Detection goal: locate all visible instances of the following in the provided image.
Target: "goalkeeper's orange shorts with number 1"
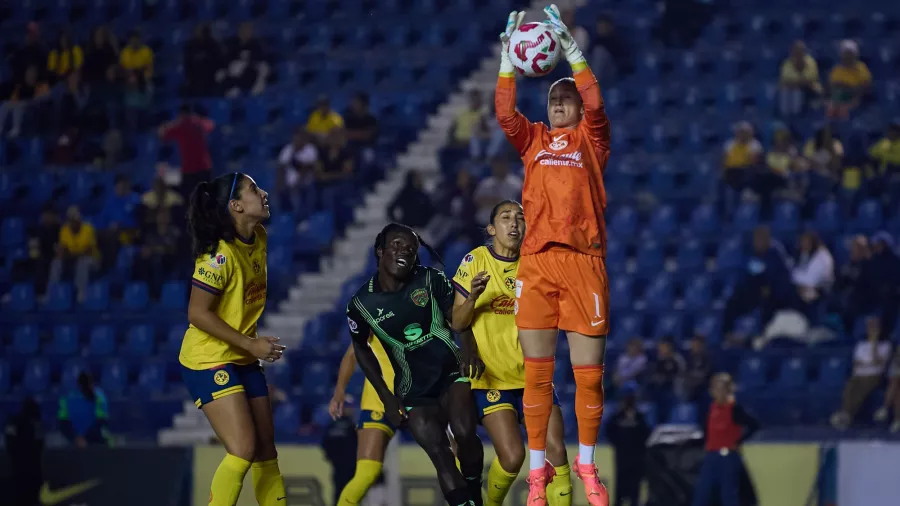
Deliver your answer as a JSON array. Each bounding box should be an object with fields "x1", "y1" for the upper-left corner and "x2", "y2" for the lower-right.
[{"x1": 515, "y1": 247, "x2": 609, "y2": 336}]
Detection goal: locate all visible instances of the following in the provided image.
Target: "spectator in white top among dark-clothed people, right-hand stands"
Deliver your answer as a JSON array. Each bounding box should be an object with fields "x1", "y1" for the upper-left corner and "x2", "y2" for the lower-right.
[{"x1": 791, "y1": 230, "x2": 834, "y2": 308}]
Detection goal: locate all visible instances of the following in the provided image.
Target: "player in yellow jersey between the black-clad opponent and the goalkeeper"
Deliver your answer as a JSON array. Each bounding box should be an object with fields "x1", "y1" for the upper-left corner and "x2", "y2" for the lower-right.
[{"x1": 453, "y1": 200, "x2": 572, "y2": 506}]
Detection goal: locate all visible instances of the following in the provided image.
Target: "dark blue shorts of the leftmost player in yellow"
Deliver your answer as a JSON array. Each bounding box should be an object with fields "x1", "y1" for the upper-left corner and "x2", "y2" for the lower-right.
[{"x1": 181, "y1": 362, "x2": 269, "y2": 408}]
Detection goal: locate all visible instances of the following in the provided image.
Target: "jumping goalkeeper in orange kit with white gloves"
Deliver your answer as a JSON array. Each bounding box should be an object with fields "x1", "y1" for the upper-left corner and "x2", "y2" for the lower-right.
[{"x1": 495, "y1": 5, "x2": 610, "y2": 506}]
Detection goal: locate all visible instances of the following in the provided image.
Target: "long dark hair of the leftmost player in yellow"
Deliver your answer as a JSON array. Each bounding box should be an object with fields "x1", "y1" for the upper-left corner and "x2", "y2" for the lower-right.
[{"x1": 188, "y1": 172, "x2": 247, "y2": 257}]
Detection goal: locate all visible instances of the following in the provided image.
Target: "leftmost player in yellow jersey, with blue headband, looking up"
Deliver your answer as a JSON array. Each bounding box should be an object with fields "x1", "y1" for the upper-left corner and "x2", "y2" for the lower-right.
[{"x1": 185, "y1": 172, "x2": 286, "y2": 506}]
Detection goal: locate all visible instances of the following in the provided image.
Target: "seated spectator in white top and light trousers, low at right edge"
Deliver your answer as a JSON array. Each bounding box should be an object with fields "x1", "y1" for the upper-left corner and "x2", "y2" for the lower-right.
[{"x1": 831, "y1": 316, "x2": 891, "y2": 430}]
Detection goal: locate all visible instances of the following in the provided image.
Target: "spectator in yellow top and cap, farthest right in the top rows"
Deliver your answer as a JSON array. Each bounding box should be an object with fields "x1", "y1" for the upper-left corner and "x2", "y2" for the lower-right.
[{"x1": 828, "y1": 39, "x2": 872, "y2": 119}]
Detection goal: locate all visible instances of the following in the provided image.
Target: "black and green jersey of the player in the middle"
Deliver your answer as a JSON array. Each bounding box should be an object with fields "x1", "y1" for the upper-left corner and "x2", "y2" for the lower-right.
[{"x1": 347, "y1": 266, "x2": 460, "y2": 407}]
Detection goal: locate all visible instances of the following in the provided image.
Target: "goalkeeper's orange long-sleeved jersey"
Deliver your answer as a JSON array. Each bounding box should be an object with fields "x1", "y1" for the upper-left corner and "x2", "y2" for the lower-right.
[{"x1": 494, "y1": 68, "x2": 609, "y2": 257}]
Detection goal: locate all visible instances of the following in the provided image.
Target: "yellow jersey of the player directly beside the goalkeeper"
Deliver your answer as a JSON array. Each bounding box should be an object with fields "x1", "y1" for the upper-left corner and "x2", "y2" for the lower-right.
[{"x1": 453, "y1": 246, "x2": 525, "y2": 390}]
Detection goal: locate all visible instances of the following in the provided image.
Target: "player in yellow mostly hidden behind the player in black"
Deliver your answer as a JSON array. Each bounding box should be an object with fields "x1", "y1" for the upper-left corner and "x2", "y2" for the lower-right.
[{"x1": 328, "y1": 336, "x2": 397, "y2": 506}]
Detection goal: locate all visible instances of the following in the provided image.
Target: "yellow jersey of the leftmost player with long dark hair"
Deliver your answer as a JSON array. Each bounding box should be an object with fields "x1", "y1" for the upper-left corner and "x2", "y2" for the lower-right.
[{"x1": 178, "y1": 225, "x2": 267, "y2": 370}]
